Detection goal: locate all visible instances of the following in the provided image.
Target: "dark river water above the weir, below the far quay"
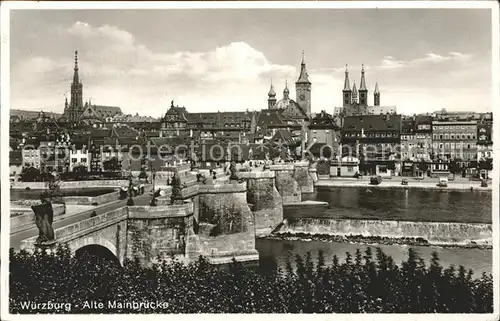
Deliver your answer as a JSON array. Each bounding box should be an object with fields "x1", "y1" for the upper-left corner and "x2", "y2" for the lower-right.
[{"x1": 296, "y1": 187, "x2": 492, "y2": 224}]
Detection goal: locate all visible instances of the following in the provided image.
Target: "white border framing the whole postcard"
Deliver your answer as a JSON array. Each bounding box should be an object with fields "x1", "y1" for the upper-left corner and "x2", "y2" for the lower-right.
[{"x1": 0, "y1": 1, "x2": 500, "y2": 321}]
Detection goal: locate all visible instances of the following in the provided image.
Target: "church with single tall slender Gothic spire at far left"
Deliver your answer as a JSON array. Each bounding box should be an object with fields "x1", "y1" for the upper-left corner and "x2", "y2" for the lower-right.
[{"x1": 59, "y1": 51, "x2": 123, "y2": 124}]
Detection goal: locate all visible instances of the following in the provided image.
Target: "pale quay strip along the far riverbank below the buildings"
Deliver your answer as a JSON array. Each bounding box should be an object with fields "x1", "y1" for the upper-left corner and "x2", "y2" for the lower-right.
[{"x1": 314, "y1": 177, "x2": 492, "y2": 192}]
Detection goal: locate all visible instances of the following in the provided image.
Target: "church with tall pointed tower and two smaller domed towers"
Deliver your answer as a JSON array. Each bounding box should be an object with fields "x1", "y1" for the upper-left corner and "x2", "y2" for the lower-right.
[{"x1": 267, "y1": 53, "x2": 311, "y2": 120}]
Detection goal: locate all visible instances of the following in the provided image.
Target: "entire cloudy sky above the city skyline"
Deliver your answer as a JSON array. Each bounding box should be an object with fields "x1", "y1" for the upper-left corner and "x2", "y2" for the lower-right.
[{"x1": 10, "y1": 9, "x2": 492, "y2": 117}]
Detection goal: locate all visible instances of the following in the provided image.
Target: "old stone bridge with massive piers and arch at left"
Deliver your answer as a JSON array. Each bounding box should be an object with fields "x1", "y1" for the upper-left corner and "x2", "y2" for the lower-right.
[{"x1": 21, "y1": 164, "x2": 314, "y2": 264}]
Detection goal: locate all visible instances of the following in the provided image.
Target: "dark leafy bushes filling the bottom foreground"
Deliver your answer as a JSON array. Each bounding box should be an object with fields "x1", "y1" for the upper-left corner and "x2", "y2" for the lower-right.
[{"x1": 9, "y1": 247, "x2": 493, "y2": 313}]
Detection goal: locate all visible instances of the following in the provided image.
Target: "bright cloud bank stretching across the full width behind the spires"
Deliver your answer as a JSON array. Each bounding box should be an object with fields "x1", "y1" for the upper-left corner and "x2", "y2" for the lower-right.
[{"x1": 11, "y1": 21, "x2": 491, "y2": 116}]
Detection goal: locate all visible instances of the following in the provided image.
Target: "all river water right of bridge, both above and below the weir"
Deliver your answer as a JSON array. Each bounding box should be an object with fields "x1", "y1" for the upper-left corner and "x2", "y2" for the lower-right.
[{"x1": 256, "y1": 187, "x2": 493, "y2": 277}]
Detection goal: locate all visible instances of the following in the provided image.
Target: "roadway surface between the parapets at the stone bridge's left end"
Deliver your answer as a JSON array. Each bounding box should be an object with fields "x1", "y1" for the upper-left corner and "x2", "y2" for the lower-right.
[{"x1": 9, "y1": 194, "x2": 151, "y2": 251}]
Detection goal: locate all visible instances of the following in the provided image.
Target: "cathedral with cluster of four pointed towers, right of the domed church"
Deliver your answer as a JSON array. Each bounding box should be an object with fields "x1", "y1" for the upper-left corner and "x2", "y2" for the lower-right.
[{"x1": 334, "y1": 65, "x2": 396, "y2": 116}]
